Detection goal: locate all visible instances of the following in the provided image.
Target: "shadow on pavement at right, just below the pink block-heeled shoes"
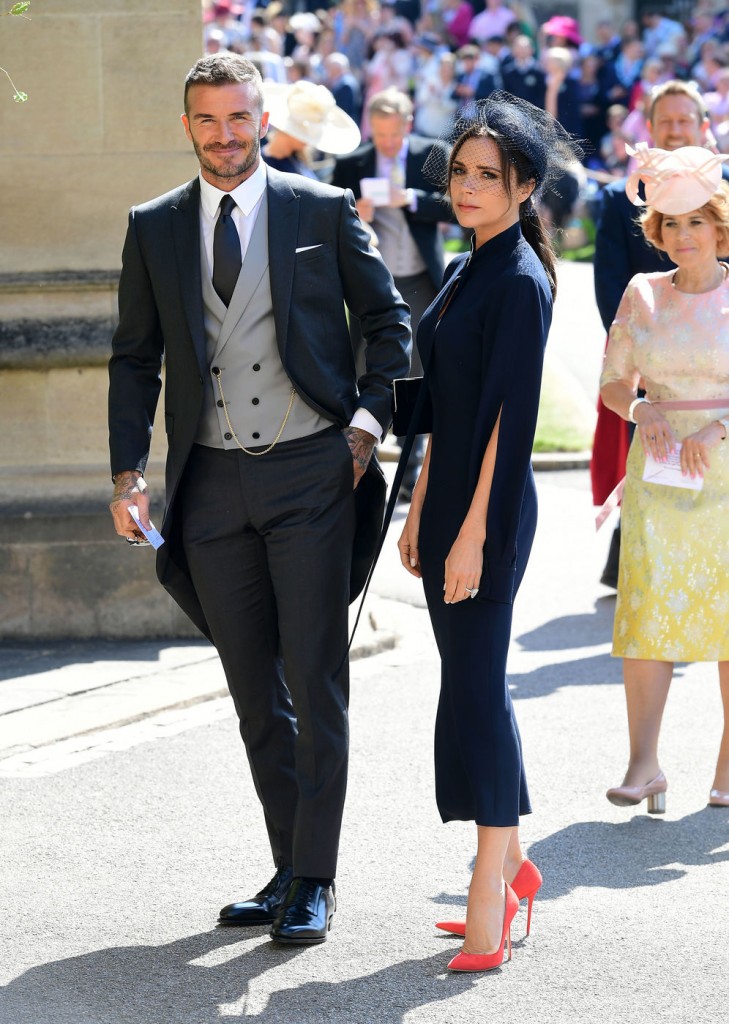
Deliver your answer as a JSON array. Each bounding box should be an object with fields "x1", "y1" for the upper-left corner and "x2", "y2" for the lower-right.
[{"x1": 528, "y1": 807, "x2": 729, "y2": 899}]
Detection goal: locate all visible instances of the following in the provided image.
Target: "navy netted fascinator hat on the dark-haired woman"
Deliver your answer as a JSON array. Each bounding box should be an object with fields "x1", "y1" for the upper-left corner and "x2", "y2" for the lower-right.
[{"x1": 423, "y1": 90, "x2": 585, "y2": 200}]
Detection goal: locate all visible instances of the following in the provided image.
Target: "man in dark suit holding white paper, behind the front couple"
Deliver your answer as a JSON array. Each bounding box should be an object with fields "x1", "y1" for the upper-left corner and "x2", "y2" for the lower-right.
[{"x1": 332, "y1": 89, "x2": 452, "y2": 501}]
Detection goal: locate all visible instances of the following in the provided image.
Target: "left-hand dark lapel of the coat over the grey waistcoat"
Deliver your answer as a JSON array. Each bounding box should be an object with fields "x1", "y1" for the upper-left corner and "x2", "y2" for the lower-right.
[{"x1": 172, "y1": 178, "x2": 208, "y2": 374}]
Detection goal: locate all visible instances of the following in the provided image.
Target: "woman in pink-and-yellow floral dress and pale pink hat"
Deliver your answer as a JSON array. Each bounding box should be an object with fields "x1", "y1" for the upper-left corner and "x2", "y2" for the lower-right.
[{"x1": 600, "y1": 146, "x2": 729, "y2": 813}]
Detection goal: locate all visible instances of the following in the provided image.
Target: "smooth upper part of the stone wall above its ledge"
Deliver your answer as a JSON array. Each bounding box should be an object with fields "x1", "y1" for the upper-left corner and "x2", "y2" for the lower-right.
[{"x1": 0, "y1": 0, "x2": 203, "y2": 273}]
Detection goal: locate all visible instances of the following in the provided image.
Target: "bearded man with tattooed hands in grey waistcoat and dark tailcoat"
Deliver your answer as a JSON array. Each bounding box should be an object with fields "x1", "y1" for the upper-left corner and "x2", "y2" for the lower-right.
[{"x1": 110, "y1": 54, "x2": 410, "y2": 944}]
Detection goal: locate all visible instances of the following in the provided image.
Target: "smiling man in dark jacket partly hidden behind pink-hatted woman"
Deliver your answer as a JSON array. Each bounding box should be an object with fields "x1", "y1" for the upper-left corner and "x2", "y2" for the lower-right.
[{"x1": 591, "y1": 80, "x2": 729, "y2": 588}]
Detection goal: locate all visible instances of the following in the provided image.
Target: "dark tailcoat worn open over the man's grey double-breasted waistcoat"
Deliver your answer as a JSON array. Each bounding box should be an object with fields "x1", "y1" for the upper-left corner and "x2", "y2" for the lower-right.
[{"x1": 109, "y1": 168, "x2": 411, "y2": 633}]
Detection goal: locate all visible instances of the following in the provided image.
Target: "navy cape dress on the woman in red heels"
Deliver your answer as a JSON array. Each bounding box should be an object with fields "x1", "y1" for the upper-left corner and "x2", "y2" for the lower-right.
[{"x1": 418, "y1": 224, "x2": 552, "y2": 827}]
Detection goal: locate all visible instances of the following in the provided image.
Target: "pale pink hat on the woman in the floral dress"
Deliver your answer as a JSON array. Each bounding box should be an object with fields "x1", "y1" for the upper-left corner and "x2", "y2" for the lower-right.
[{"x1": 626, "y1": 142, "x2": 729, "y2": 216}]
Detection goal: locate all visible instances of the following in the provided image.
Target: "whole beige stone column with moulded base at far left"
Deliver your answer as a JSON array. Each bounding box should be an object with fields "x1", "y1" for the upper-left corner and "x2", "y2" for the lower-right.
[{"x1": 0, "y1": 0, "x2": 203, "y2": 637}]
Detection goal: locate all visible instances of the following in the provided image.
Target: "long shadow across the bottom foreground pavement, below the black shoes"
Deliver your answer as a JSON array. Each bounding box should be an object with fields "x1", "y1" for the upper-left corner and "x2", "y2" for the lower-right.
[{"x1": 0, "y1": 930, "x2": 487, "y2": 1024}]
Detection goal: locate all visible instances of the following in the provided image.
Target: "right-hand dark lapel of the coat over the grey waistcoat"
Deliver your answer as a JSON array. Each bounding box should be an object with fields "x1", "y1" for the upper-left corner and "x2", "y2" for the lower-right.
[{"x1": 266, "y1": 167, "x2": 301, "y2": 366}]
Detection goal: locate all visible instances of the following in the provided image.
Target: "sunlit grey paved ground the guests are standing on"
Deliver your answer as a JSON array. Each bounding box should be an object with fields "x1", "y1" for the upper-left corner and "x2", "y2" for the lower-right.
[{"x1": 0, "y1": 260, "x2": 729, "y2": 1024}]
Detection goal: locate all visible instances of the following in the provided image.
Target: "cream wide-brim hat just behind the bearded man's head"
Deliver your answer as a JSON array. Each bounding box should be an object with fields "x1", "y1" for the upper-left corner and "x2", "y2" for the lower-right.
[{"x1": 263, "y1": 81, "x2": 361, "y2": 155}]
